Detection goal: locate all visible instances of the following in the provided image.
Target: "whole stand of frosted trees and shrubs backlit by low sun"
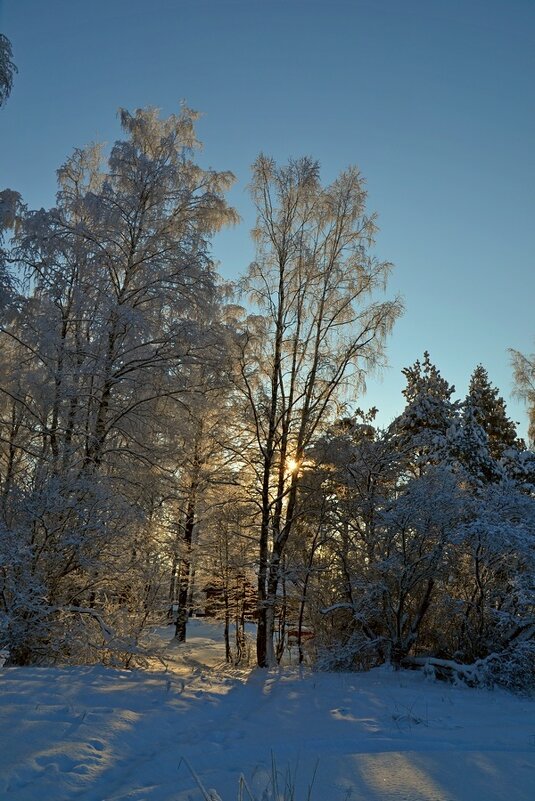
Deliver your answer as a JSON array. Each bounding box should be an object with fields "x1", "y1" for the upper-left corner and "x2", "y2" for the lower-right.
[{"x1": 0, "y1": 101, "x2": 535, "y2": 689}]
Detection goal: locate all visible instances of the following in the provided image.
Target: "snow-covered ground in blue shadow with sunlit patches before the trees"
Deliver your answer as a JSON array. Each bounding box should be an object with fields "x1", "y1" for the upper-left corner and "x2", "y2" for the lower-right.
[{"x1": 0, "y1": 620, "x2": 535, "y2": 801}]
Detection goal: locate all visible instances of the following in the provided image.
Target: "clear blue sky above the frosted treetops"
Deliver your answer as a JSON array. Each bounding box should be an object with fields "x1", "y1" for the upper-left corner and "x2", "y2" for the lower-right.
[{"x1": 0, "y1": 0, "x2": 535, "y2": 435}]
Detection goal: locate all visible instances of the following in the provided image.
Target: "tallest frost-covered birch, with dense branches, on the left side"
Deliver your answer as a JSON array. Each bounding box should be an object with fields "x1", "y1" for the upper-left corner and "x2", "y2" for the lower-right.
[{"x1": 0, "y1": 108, "x2": 234, "y2": 661}]
